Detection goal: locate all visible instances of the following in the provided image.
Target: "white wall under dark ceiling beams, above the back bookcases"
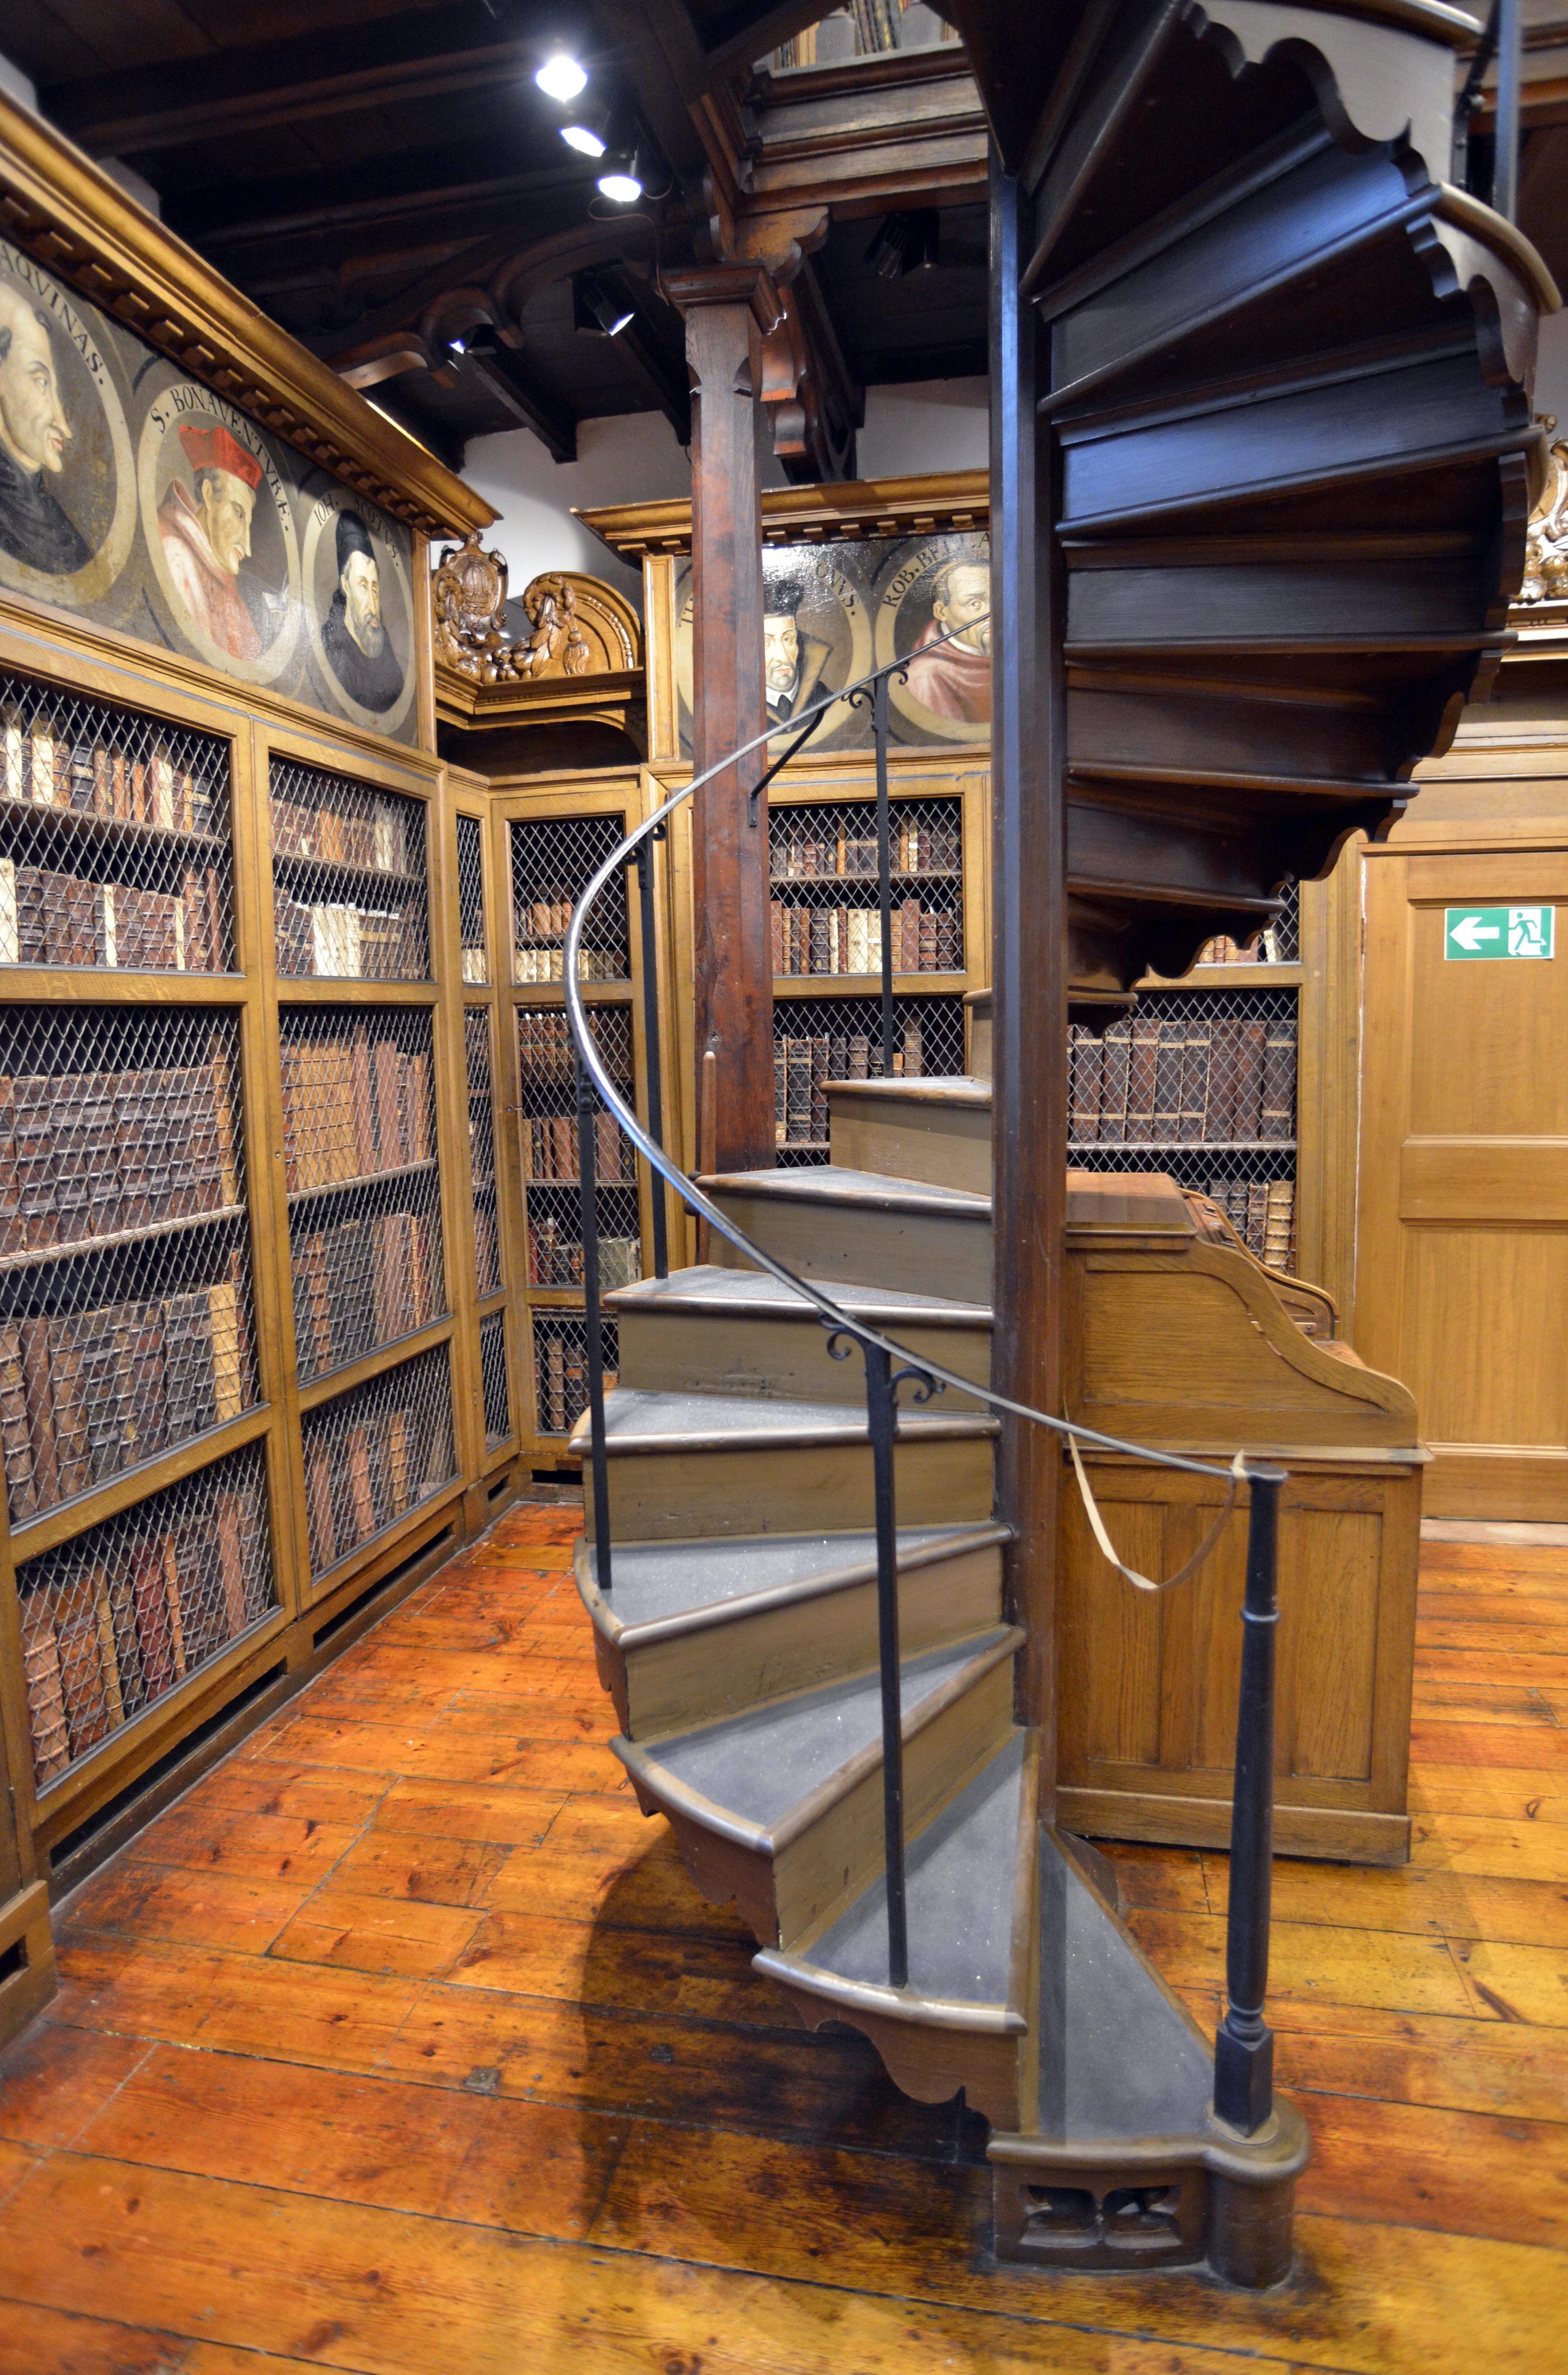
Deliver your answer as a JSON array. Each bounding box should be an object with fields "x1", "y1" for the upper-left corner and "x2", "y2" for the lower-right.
[{"x1": 463, "y1": 380, "x2": 988, "y2": 601}]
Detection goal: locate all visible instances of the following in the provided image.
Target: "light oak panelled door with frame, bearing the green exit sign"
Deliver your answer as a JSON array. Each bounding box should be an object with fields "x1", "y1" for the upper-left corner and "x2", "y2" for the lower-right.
[{"x1": 1359, "y1": 821, "x2": 1568, "y2": 1522}]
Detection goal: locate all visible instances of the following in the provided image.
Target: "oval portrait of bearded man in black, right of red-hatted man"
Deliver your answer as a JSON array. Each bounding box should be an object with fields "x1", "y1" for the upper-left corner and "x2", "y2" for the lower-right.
[{"x1": 304, "y1": 484, "x2": 416, "y2": 734}]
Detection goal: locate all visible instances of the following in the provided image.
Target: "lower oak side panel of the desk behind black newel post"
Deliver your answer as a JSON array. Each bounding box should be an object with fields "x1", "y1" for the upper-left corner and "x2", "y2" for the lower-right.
[{"x1": 1059, "y1": 1453, "x2": 1421, "y2": 1862}]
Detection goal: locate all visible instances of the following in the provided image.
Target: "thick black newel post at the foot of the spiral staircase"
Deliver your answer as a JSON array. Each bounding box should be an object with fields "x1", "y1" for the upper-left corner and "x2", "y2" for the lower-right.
[{"x1": 1214, "y1": 1468, "x2": 1285, "y2": 2135}]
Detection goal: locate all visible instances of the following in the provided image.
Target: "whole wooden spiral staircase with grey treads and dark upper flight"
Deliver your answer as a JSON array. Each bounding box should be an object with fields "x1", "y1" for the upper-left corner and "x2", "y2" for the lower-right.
[{"x1": 565, "y1": 0, "x2": 1556, "y2": 2285}]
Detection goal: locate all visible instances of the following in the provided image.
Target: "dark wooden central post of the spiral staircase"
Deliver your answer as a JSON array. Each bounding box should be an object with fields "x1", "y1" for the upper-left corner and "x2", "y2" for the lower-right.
[{"x1": 991, "y1": 161, "x2": 1067, "y2": 1776}]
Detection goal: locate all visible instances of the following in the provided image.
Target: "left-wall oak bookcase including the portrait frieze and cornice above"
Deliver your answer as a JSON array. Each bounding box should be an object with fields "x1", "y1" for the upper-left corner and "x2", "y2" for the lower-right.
[{"x1": 0, "y1": 100, "x2": 518, "y2": 2038}]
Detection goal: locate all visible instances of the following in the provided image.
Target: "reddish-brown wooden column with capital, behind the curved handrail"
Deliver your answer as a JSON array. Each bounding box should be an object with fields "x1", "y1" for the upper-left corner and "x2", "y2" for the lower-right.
[{"x1": 665, "y1": 264, "x2": 779, "y2": 1171}]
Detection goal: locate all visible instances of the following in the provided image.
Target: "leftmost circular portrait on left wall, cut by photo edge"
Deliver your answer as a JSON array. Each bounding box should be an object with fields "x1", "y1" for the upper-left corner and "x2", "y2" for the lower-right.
[{"x1": 0, "y1": 244, "x2": 135, "y2": 606}]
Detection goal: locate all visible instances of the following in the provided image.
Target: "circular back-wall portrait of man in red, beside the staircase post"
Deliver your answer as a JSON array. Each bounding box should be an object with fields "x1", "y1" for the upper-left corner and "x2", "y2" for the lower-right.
[{"x1": 877, "y1": 534, "x2": 991, "y2": 741}]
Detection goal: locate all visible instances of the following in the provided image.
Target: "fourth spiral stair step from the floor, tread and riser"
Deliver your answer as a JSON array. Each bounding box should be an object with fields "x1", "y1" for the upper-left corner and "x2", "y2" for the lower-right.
[{"x1": 575, "y1": 1525, "x2": 1012, "y2": 1741}]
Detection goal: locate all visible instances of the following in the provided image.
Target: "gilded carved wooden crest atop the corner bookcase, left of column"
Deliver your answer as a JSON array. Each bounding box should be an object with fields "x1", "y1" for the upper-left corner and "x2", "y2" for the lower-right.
[{"x1": 430, "y1": 534, "x2": 642, "y2": 684}]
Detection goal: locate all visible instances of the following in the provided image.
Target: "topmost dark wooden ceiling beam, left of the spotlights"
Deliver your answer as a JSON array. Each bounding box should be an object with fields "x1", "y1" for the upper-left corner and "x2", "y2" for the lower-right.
[{"x1": 40, "y1": 7, "x2": 558, "y2": 157}]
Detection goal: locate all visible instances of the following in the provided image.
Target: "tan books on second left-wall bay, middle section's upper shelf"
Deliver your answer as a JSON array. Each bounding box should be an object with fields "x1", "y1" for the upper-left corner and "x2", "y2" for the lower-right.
[{"x1": 283, "y1": 1024, "x2": 435, "y2": 1195}]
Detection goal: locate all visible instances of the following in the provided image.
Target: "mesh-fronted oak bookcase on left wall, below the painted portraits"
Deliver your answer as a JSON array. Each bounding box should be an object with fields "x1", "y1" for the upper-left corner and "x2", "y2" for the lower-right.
[{"x1": 0, "y1": 617, "x2": 532, "y2": 1954}]
